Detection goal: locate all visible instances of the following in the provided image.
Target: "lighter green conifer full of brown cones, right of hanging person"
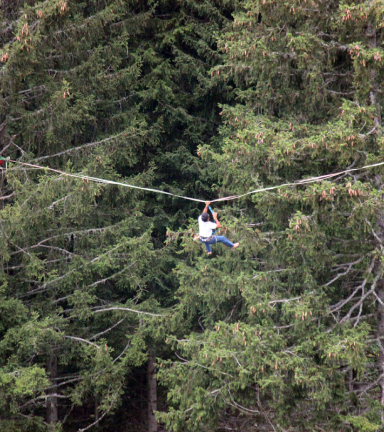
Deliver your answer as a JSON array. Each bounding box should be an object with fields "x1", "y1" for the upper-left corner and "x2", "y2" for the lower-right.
[{"x1": 161, "y1": 0, "x2": 384, "y2": 431}]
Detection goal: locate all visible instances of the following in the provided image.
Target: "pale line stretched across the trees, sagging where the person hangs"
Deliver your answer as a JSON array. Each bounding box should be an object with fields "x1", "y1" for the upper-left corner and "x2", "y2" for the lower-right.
[{"x1": 9, "y1": 159, "x2": 384, "y2": 203}]
